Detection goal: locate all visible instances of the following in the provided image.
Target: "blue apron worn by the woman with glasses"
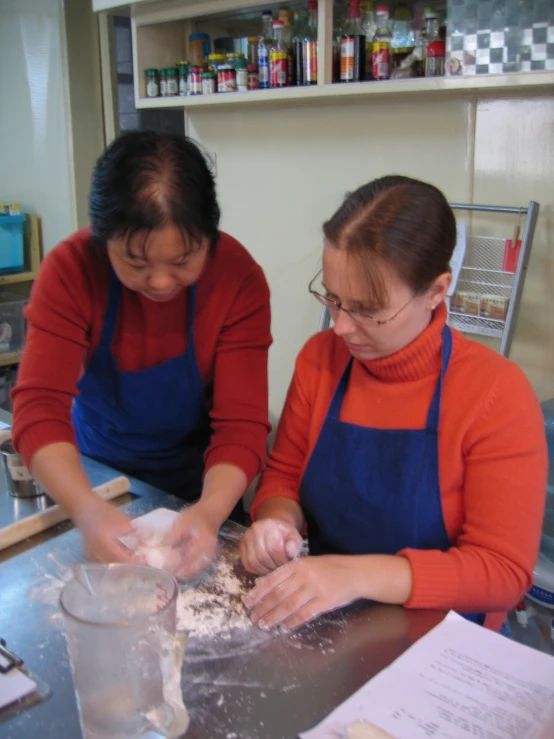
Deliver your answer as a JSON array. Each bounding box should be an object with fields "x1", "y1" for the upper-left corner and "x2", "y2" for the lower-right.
[{"x1": 300, "y1": 326, "x2": 485, "y2": 624}]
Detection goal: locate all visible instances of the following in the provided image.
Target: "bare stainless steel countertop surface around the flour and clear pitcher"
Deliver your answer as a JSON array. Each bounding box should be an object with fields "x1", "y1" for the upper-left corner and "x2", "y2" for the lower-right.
[{"x1": 0, "y1": 448, "x2": 442, "y2": 739}]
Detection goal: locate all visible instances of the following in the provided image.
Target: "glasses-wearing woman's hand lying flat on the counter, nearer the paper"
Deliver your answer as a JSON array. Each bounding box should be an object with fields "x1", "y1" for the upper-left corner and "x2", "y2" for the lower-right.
[{"x1": 244, "y1": 555, "x2": 362, "y2": 629}]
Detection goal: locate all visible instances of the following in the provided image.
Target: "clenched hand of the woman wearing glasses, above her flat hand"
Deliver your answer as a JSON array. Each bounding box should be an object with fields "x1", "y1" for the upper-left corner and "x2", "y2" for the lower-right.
[{"x1": 239, "y1": 518, "x2": 302, "y2": 575}]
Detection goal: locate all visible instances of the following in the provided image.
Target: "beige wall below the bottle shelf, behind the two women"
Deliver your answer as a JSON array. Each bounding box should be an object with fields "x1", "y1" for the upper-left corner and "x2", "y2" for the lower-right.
[{"x1": 187, "y1": 91, "x2": 554, "y2": 416}]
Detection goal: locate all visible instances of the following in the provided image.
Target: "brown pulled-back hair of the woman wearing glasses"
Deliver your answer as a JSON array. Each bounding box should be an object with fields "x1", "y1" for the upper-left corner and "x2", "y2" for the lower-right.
[{"x1": 323, "y1": 175, "x2": 456, "y2": 307}]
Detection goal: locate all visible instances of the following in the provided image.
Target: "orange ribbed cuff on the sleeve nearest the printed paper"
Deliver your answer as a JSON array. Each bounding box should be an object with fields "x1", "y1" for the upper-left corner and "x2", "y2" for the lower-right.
[{"x1": 398, "y1": 549, "x2": 458, "y2": 611}]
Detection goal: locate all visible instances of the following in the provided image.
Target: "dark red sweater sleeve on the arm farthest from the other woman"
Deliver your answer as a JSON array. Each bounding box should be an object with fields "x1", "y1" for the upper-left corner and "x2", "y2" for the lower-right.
[{"x1": 13, "y1": 243, "x2": 91, "y2": 466}]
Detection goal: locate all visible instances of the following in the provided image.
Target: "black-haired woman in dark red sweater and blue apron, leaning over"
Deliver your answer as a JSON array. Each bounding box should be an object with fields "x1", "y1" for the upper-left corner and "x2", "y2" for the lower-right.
[{"x1": 13, "y1": 132, "x2": 271, "y2": 574}]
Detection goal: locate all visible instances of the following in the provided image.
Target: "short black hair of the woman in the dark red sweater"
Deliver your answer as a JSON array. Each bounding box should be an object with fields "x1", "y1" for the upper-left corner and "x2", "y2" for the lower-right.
[{"x1": 89, "y1": 131, "x2": 220, "y2": 258}]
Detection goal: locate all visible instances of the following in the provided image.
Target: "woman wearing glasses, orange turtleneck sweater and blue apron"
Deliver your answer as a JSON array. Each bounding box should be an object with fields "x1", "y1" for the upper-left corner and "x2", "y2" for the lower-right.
[{"x1": 241, "y1": 177, "x2": 547, "y2": 629}]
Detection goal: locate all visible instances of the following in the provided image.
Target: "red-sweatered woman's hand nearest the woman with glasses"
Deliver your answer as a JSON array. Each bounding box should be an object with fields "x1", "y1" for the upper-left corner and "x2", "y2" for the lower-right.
[{"x1": 164, "y1": 501, "x2": 218, "y2": 579}]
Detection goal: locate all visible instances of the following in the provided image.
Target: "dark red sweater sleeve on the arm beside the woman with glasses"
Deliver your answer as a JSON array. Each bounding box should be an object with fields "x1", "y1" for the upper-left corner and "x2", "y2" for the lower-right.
[{"x1": 205, "y1": 265, "x2": 271, "y2": 484}]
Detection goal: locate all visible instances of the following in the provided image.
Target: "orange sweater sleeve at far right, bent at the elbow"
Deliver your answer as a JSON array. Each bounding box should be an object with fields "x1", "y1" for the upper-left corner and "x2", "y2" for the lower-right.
[{"x1": 399, "y1": 363, "x2": 547, "y2": 613}]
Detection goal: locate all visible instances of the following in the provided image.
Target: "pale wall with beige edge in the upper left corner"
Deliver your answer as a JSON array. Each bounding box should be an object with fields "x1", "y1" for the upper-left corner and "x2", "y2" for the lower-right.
[{"x1": 0, "y1": 0, "x2": 103, "y2": 251}]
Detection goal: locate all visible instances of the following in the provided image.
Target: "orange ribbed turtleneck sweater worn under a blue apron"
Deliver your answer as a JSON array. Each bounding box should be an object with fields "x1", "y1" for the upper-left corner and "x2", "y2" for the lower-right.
[{"x1": 252, "y1": 306, "x2": 547, "y2": 630}]
